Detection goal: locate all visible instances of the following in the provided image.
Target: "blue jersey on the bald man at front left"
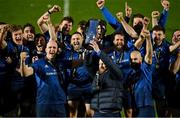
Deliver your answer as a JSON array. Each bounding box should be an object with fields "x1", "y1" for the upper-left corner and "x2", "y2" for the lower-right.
[{"x1": 32, "y1": 58, "x2": 66, "y2": 104}]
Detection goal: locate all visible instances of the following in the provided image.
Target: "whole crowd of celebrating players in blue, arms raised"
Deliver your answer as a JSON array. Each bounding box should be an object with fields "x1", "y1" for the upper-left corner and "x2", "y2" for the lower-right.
[{"x1": 0, "y1": 0, "x2": 180, "y2": 117}]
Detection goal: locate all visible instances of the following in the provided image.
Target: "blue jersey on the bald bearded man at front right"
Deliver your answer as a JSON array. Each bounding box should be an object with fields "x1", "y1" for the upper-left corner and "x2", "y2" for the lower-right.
[{"x1": 129, "y1": 62, "x2": 154, "y2": 107}]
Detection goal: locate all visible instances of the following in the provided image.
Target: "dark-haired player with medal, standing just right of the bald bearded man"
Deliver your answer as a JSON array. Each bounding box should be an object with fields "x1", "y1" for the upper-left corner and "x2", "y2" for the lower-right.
[{"x1": 152, "y1": 26, "x2": 170, "y2": 117}]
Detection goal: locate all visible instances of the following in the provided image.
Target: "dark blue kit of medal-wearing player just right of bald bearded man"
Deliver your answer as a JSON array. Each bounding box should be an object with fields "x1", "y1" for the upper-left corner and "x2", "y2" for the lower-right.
[{"x1": 152, "y1": 41, "x2": 170, "y2": 99}]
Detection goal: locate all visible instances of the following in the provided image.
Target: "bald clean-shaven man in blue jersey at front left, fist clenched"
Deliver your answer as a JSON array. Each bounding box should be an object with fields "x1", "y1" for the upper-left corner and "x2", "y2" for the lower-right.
[{"x1": 21, "y1": 40, "x2": 66, "y2": 117}]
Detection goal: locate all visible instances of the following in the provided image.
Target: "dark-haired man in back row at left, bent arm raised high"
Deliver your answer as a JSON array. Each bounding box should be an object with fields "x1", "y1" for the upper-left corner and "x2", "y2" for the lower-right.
[{"x1": 37, "y1": 5, "x2": 74, "y2": 50}]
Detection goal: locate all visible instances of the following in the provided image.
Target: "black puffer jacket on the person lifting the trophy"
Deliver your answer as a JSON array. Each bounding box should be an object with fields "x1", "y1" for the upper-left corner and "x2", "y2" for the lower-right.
[{"x1": 85, "y1": 52, "x2": 124, "y2": 111}]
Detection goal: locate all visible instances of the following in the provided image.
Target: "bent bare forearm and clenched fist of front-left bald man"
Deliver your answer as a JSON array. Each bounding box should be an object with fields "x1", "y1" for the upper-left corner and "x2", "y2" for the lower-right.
[{"x1": 20, "y1": 52, "x2": 34, "y2": 77}]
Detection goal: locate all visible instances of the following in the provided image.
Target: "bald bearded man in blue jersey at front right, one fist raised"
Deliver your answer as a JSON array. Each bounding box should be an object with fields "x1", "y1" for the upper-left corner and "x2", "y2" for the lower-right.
[{"x1": 126, "y1": 28, "x2": 155, "y2": 117}]
